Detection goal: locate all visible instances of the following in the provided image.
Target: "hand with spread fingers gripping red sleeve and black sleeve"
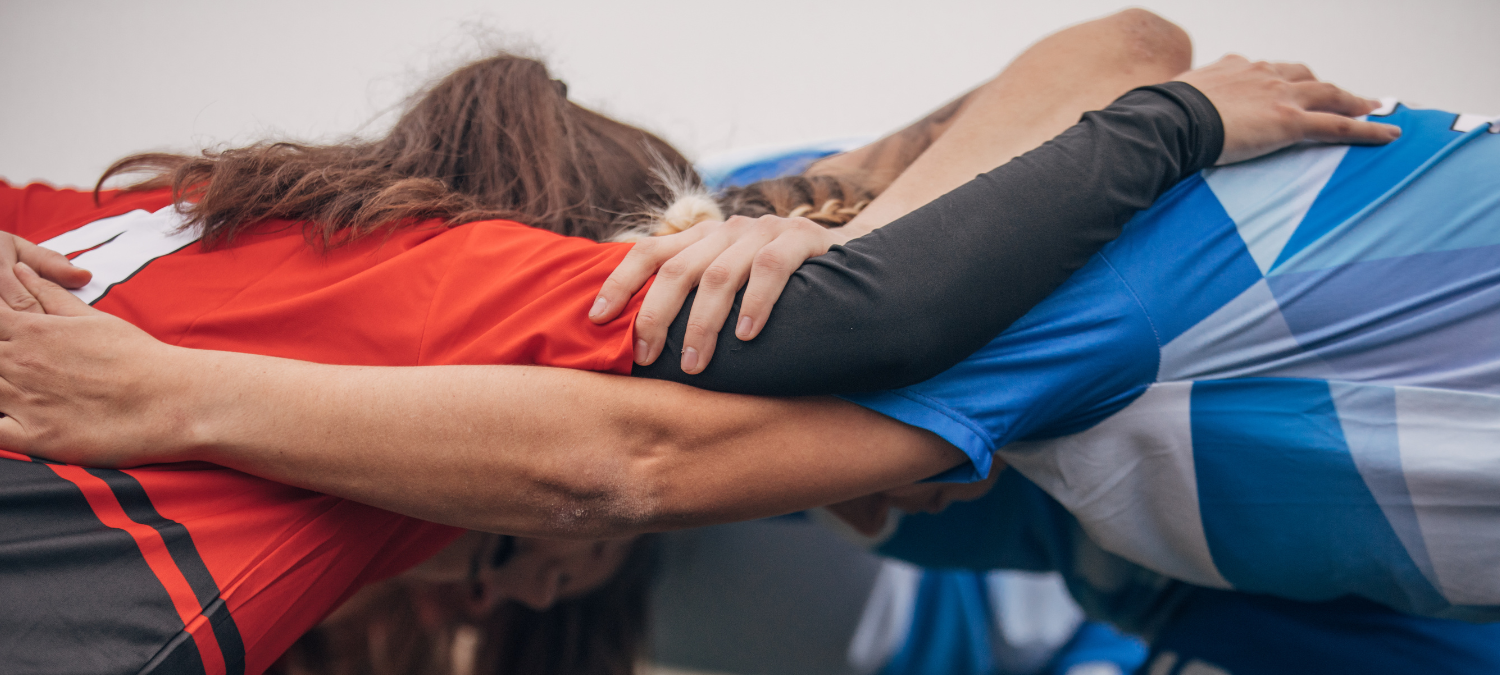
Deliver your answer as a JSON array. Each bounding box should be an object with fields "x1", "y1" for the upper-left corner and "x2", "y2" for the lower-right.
[{"x1": 588, "y1": 216, "x2": 849, "y2": 374}]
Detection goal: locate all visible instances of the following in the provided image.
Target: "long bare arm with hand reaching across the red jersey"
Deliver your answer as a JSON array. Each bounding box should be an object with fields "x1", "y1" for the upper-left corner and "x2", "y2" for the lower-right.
[{"x1": 0, "y1": 267, "x2": 963, "y2": 537}]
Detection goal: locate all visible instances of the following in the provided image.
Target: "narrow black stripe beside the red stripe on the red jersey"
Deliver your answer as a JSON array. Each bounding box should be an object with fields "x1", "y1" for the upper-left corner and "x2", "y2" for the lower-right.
[{"x1": 89, "y1": 470, "x2": 245, "y2": 675}]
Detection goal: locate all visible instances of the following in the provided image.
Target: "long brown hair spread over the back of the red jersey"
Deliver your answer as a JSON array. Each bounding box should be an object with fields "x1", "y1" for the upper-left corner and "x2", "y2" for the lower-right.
[{"x1": 95, "y1": 54, "x2": 696, "y2": 248}]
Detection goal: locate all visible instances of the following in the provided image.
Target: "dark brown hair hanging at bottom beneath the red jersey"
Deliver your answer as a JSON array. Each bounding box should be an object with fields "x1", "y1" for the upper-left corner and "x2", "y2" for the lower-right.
[{"x1": 269, "y1": 536, "x2": 656, "y2": 675}]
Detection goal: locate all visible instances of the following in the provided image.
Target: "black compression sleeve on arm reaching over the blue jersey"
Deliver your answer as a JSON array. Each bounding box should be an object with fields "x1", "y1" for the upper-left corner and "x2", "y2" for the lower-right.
[{"x1": 633, "y1": 83, "x2": 1224, "y2": 396}]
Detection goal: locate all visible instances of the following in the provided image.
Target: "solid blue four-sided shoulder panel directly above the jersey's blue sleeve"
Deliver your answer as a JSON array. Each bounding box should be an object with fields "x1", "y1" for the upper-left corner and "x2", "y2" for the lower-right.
[{"x1": 1101, "y1": 176, "x2": 1262, "y2": 345}]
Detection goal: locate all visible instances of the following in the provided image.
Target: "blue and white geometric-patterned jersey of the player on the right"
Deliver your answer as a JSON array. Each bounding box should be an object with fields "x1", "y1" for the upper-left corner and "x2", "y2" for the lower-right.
[{"x1": 848, "y1": 104, "x2": 1500, "y2": 620}]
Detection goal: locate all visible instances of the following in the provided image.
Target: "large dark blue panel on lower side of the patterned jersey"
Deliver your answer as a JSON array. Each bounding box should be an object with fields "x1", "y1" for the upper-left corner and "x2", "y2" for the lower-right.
[{"x1": 1191, "y1": 378, "x2": 1448, "y2": 611}]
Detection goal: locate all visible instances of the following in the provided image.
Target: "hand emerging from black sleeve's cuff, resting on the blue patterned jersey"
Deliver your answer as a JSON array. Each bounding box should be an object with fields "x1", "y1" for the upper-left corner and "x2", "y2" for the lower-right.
[{"x1": 1178, "y1": 54, "x2": 1401, "y2": 165}]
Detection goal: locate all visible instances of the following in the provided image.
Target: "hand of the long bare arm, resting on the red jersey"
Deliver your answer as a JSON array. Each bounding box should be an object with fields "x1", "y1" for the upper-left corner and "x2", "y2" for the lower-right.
[{"x1": 0, "y1": 263, "x2": 191, "y2": 467}]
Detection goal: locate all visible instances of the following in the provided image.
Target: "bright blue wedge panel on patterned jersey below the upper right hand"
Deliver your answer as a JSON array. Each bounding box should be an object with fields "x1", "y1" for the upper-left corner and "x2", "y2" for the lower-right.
[{"x1": 1271, "y1": 105, "x2": 1463, "y2": 270}]
